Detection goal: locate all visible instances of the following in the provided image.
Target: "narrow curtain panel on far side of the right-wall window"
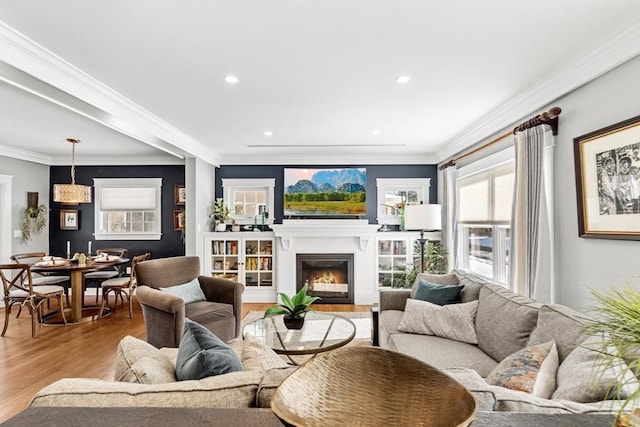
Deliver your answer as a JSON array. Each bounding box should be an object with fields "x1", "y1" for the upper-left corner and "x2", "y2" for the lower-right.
[{"x1": 438, "y1": 165, "x2": 458, "y2": 271}]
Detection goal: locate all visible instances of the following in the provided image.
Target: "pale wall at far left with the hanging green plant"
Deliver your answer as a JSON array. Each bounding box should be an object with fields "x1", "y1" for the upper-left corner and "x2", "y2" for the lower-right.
[{"x1": 0, "y1": 156, "x2": 50, "y2": 253}]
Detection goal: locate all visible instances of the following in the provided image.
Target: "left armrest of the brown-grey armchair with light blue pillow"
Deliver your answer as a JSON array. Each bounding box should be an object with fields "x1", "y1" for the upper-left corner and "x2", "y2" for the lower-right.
[{"x1": 136, "y1": 286, "x2": 185, "y2": 348}]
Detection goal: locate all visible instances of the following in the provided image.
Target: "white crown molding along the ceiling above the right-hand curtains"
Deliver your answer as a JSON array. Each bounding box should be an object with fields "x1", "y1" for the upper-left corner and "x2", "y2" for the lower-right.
[{"x1": 436, "y1": 23, "x2": 640, "y2": 163}]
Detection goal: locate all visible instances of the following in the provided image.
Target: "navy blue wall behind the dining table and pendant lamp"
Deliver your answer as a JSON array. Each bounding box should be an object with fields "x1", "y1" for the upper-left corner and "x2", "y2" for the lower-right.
[{"x1": 49, "y1": 165, "x2": 184, "y2": 258}]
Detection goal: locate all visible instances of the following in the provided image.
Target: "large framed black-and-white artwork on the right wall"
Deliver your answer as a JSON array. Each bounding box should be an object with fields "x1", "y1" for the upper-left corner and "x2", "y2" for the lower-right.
[{"x1": 573, "y1": 116, "x2": 640, "y2": 240}]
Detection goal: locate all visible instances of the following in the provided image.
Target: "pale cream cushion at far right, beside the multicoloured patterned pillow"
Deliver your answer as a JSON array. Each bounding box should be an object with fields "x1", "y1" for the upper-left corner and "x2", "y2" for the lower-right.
[{"x1": 552, "y1": 337, "x2": 640, "y2": 403}]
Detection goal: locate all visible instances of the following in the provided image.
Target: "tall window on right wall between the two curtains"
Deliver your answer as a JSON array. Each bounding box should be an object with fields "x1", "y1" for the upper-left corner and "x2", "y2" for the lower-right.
[{"x1": 457, "y1": 150, "x2": 515, "y2": 283}]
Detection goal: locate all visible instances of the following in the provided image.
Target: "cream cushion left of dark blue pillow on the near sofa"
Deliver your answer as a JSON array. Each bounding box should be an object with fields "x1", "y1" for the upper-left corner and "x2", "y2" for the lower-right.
[{"x1": 114, "y1": 335, "x2": 176, "y2": 384}]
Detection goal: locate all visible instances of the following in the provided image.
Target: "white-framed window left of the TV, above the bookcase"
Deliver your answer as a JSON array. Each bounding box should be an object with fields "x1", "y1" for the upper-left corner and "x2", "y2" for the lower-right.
[{"x1": 222, "y1": 178, "x2": 276, "y2": 224}]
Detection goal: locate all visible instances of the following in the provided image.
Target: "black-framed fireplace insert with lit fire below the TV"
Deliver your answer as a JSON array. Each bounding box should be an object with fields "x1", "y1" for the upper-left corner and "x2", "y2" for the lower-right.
[{"x1": 296, "y1": 253, "x2": 353, "y2": 304}]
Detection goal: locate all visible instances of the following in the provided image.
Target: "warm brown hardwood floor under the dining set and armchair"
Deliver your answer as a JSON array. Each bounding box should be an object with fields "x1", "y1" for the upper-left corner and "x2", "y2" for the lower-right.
[{"x1": 0, "y1": 295, "x2": 369, "y2": 423}]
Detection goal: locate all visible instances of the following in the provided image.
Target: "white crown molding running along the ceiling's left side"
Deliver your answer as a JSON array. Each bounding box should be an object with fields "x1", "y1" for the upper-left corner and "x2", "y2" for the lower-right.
[{"x1": 0, "y1": 21, "x2": 219, "y2": 165}]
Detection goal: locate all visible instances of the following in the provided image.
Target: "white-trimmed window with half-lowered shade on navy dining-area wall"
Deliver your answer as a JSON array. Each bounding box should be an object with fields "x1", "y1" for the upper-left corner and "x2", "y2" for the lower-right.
[{"x1": 93, "y1": 178, "x2": 162, "y2": 240}]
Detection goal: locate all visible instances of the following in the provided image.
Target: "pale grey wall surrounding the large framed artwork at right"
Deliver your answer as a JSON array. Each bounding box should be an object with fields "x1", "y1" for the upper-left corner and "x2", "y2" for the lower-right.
[{"x1": 550, "y1": 57, "x2": 640, "y2": 310}]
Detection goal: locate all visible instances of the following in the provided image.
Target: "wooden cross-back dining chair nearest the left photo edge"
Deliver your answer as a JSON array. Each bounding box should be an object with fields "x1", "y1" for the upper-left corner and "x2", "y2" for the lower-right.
[{"x1": 0, "y1": 264, "x2": 67, "y2": 338}]
